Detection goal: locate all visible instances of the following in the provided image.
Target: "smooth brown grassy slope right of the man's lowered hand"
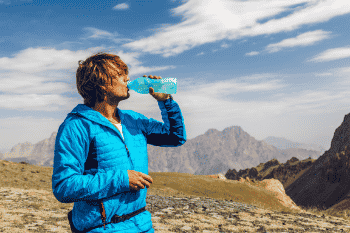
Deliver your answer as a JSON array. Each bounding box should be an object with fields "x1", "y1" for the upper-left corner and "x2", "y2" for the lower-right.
[{"x1": 148, "y1": 172, "x2": 350, "y2": 220}]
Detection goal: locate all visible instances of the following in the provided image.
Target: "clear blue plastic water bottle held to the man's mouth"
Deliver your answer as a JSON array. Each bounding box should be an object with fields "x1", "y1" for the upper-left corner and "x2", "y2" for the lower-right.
[{"x1": 127, "y1": 77, "x2": 177, "y2": 94}]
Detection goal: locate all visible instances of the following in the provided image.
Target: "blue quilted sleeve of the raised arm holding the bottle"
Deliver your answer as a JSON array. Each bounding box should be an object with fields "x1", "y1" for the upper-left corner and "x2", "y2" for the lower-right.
[{"x1": 142, "y1": 99, "x2": 186, "y2": 147}]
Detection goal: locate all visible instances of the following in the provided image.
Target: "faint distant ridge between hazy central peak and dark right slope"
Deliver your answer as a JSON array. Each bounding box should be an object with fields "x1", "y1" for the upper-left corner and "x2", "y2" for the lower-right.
[{"x1": 263, "y1": 136, "x2": 325, "y2": 155}]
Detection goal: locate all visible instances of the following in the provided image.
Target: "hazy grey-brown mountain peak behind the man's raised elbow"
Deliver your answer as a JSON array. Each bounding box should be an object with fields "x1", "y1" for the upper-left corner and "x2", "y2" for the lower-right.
[{"x1": 148, "y1": 126, "x2": 282, "y2": 175}]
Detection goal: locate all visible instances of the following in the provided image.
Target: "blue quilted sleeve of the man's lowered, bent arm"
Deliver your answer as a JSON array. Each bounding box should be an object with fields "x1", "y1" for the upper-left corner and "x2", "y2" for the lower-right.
[{"x1": 52, "y1": 119, "x2": 130, "y2": 203}]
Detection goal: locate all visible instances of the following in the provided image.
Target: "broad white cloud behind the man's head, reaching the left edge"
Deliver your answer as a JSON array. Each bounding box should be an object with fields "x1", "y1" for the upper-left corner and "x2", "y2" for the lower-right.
[{"x1": 0, "y1": 48, "x2": 175, "y2": 111}]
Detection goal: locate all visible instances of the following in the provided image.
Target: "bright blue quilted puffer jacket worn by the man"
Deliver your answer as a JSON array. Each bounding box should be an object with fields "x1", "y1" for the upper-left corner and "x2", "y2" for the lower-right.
[{"x1": 52, "y1": 99, "x2": 186, "y2": 233}]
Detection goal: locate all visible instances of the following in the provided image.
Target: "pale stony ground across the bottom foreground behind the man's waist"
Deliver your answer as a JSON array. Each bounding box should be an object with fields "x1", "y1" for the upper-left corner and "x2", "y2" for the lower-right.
[{"x1": 0, "y1": 187, "x2": 350, "y2": 233}]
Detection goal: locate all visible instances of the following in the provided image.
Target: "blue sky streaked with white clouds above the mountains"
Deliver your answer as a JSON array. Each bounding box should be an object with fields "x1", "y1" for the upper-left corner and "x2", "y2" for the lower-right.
[{"x1": 0, "y1": 0, "x2": 350, "y2": 150}]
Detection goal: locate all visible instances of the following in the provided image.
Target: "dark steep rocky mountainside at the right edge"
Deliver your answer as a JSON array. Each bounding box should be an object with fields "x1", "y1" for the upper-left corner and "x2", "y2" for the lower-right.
[{"x1": 286, "y1": 114, "x2": 350, "y2": 209}]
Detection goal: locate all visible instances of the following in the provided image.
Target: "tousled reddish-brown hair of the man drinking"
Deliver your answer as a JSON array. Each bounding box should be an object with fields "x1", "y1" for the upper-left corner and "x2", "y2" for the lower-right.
[{"x1": 76, "y1": 53, "x2": 129, "y2": 107}]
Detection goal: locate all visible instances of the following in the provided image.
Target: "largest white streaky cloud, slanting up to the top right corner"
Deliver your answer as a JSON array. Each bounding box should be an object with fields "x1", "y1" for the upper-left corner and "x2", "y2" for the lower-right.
[{"x1": 124, "y1": 0, "x2": 350, "y2": 57}]
